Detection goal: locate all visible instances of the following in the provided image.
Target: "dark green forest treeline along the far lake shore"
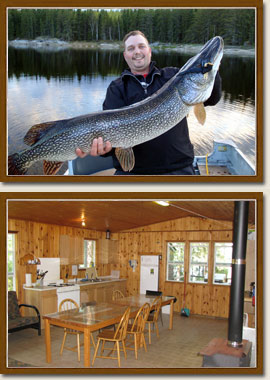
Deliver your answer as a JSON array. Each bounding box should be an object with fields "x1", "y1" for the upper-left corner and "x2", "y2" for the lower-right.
[{"x1": 8, "y1": 9, "x2": 255, "y2": 46}]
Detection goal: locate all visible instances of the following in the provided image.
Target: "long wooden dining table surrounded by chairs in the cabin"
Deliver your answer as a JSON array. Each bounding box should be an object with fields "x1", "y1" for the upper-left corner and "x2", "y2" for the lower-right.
[{"x1": 43, "y1": 295, "x2": 174, "y2": 367}]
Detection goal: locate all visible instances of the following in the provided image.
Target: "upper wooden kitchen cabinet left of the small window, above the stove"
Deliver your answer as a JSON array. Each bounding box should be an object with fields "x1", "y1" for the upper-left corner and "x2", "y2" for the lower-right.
[{"x1": 59, "y1": 235, "x2": 84, "y2": 265}]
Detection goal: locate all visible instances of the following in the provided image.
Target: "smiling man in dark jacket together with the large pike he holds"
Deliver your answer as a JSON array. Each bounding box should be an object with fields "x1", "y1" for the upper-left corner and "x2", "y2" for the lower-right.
[{"x1": 8, "y1": 31, "x2": 224, "y2": 175}]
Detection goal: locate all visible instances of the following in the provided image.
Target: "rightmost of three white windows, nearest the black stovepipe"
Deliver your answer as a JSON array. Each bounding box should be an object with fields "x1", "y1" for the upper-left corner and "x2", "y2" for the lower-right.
[{"x1": 213, "y1": 243, "x2": 233, "y2": 285}]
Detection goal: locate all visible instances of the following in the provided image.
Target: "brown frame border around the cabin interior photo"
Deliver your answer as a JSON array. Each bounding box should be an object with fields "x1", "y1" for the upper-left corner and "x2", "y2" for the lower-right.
[{"x1": 0, "y1": 192, "x2": 264, "y2": 375}]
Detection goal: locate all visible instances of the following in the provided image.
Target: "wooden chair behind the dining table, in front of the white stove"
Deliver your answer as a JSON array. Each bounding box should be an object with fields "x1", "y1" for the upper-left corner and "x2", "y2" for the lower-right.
[{"x1": 58, "y1": 298, "x2": 96, "y2": 361}]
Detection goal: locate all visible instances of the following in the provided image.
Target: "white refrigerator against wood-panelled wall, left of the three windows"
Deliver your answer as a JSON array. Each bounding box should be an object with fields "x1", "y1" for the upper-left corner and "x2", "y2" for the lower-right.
[{"x1": 140, "y1": 255, "x2": 159, "y2": 294}]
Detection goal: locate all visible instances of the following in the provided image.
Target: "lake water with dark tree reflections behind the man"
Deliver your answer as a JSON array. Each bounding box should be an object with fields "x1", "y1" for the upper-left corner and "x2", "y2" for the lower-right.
[{"x1": 8, "y1": 47, "x2": 256, "y2": 174}]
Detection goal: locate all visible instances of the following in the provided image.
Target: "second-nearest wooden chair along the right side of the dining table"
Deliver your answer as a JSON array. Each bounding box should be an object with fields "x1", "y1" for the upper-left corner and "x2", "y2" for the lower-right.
[{"x1": 126, "y1": 303, "x2": 150, "y2": 359}]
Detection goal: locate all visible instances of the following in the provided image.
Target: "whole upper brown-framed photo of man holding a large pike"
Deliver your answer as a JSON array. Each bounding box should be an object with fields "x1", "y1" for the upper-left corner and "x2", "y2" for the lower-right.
[{"x1": 0, "y1": 0, "x2": 263, "y2": 183}]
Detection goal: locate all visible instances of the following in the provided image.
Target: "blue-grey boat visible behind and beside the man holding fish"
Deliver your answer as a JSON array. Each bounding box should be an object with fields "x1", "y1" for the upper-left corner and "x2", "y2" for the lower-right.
[{"x1": 65, "y1": 140, "x2": 255, "y2": 176}]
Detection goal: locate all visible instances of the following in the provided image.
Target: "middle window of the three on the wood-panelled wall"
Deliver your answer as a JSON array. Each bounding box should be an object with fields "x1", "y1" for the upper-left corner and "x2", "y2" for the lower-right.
[{"x1": 189, "y1": 243, "x2": 209, "y2": 283}]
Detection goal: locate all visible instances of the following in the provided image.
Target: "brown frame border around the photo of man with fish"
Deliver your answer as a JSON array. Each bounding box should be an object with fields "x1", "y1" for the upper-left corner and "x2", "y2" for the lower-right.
[{"x1": 0, "y1": 0, "x2": 263, "y2": 183}]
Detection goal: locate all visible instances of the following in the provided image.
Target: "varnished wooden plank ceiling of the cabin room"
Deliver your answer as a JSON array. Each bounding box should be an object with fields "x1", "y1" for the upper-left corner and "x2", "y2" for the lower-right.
[{"x1": 8, "y1": 199, "x2": 255, "y2": 232}]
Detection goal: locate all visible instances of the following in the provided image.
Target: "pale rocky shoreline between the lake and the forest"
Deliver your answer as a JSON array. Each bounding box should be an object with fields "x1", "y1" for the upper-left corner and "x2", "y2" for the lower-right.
[{"x1": 8, "y1": 37, "x2": 255, "y2": 57}]
